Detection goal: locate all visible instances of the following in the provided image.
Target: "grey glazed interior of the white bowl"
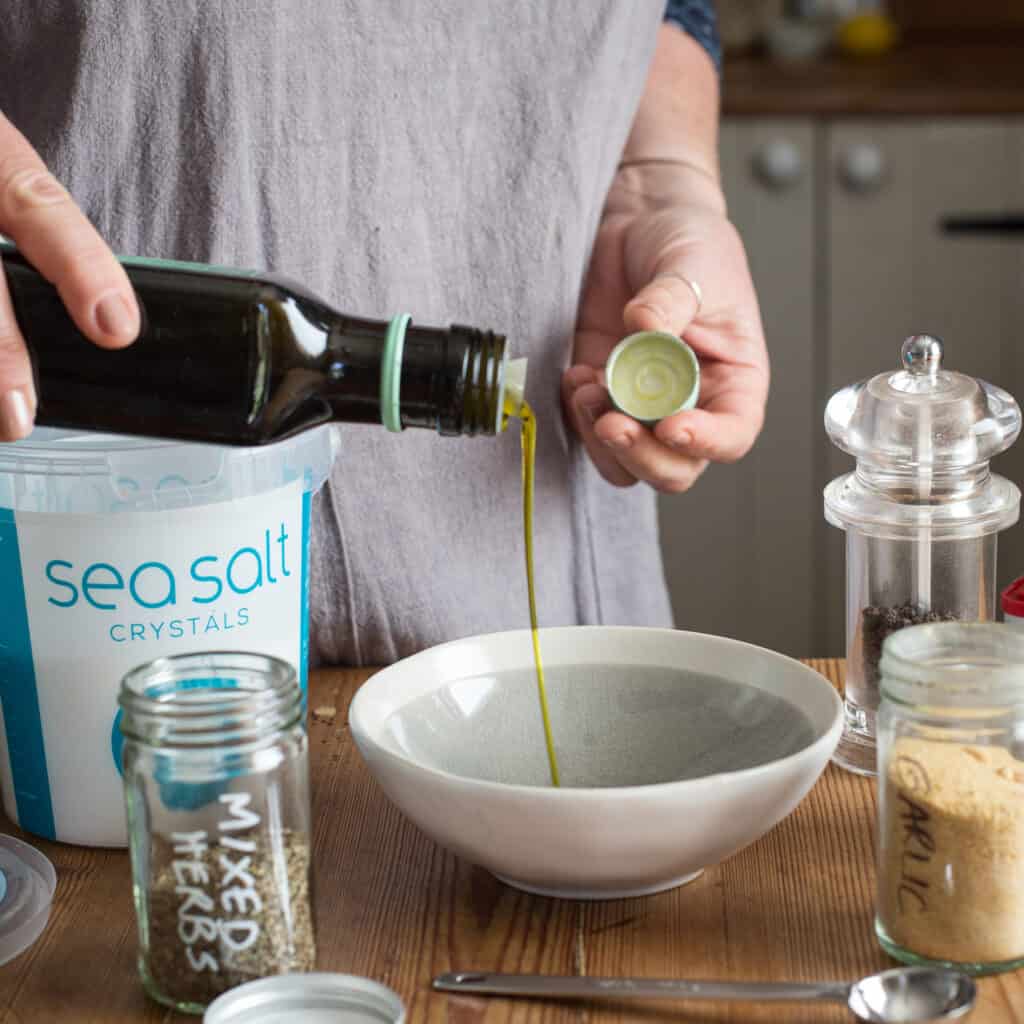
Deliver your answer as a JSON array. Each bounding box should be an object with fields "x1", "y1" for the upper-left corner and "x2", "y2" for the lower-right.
[{"x1": 382, "y1": 665, "x2": 814, "y2": 787}]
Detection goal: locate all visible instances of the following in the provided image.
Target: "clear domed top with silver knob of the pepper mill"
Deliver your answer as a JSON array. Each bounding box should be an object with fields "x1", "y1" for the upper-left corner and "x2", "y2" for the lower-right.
[{"x1": 825, "y1": 335, "x2": 1021, "y2": 473}]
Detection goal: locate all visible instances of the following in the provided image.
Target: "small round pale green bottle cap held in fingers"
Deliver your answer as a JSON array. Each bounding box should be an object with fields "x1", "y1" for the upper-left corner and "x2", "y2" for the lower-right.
[{"x1": 604, "y1": 331, "x2": 700, "y2": 423}]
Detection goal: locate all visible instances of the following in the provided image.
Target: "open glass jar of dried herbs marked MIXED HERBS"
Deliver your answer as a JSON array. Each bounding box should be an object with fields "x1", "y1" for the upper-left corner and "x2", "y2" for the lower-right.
[{"x1": 120, "y1": 652, "x2": 315, "y2": 1013}]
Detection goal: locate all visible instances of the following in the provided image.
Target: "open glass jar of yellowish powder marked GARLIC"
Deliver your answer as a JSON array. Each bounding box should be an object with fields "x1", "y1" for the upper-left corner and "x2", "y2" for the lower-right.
[{"x1": 876, "y1": 623, "x2": 1024, "y2": 974}]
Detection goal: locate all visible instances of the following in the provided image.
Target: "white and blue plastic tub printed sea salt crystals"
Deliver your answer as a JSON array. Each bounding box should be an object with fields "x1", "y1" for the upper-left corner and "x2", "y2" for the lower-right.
[{"x1": 0, "y1": 428, "x2": 334, "y2": 846}]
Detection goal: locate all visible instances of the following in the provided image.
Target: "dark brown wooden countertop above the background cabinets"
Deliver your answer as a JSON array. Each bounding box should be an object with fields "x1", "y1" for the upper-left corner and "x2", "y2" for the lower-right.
[{"x1": 723, "y1": 43, "x2": 1024, "y2": 117}]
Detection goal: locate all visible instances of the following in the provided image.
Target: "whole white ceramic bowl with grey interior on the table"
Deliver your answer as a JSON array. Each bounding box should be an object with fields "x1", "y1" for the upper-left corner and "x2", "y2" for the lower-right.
[{"x1": 349, "y1": 627, "x2": 842, "y2": 899}]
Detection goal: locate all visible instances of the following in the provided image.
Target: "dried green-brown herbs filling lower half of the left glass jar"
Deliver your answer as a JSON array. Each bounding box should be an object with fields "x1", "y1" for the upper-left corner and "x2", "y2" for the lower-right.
[{"x1": 143, "y1": 793, "x2": 315, "y2": 1005}]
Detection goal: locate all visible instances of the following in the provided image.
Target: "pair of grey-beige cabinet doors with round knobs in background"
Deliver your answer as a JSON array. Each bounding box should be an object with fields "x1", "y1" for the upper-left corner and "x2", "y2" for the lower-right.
[{"x1": 659, "y1": 117, "x2": 1024, "y2": 654}]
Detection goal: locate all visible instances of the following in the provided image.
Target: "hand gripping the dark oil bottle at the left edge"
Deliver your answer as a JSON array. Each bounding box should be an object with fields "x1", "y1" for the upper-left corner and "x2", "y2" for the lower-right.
[{"x1": 0, "y1": 113, "x2": 140, "y2": 441}]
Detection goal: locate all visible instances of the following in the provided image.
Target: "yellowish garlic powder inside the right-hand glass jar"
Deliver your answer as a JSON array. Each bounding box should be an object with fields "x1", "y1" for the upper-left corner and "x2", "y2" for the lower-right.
[{"x1": 880, "y1": 737, "x2": 1024, "y2": 964}]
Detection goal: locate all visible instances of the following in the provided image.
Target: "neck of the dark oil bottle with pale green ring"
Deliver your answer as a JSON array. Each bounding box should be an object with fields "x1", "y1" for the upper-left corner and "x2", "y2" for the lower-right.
[{"x1": 324, "y1": 316, "x2": 506, "y2": 436}]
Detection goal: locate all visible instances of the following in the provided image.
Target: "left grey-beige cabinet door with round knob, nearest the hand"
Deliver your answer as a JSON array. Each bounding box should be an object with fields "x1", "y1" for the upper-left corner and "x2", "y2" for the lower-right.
[{"x1": 659, "y1": 119, "x2": 820, "y2": 652}]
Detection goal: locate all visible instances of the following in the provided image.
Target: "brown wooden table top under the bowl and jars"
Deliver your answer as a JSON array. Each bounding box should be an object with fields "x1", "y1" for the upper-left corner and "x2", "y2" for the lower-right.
[{"x1": 0, "y1": 662, "x2": 1024, "y2": 1024}]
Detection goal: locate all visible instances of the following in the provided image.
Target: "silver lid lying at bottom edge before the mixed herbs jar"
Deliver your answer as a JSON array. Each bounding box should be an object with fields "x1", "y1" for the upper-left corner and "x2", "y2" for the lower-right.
[{"x1": 203, "y1": 973, "x2": 406, "y2": 1024}]
